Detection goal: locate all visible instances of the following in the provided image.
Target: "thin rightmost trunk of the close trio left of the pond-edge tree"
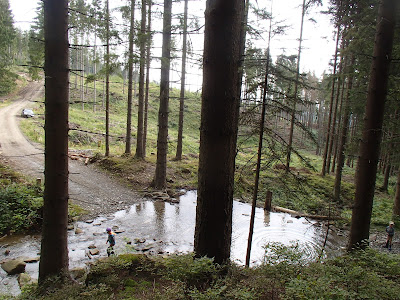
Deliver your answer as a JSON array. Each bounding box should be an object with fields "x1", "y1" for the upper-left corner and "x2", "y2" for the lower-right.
[{"x1": 143, "y1": 1, "x2": 152, "y2": 157}]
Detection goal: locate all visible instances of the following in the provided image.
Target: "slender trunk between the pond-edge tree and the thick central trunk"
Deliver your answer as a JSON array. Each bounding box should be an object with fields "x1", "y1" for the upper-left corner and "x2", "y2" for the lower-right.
[{"x1": 175, "y1": 0, "x2": 188, "y2": 160}]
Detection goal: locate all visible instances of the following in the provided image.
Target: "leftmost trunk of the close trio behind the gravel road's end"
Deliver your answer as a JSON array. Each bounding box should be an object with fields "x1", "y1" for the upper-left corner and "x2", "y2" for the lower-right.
[{"x1": 125, "y1": 0, "x2": 135, "y2": 154}]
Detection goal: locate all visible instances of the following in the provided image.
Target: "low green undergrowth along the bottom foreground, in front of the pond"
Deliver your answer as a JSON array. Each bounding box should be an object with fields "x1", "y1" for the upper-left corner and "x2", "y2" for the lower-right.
[{"x1": 17, "y1": 244, "x2": 400, "y2": 300}]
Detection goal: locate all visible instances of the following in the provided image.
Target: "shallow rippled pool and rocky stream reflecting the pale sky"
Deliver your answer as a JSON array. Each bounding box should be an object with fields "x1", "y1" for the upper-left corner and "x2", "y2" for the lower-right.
[{"x1": 0, "y1": 191, "x2": 345, "y2": 295}]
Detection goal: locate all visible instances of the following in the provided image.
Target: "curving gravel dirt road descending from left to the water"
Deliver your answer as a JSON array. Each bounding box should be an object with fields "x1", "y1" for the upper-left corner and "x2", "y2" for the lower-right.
[{"x1": 0, "y1": 82, "x2": 142, "y2": 218}]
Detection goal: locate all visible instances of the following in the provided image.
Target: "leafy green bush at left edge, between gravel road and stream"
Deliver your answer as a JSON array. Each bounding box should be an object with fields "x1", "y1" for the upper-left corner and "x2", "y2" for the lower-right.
[{"x1": 0, "y1": 184, "x2": 43, "y2": 234}]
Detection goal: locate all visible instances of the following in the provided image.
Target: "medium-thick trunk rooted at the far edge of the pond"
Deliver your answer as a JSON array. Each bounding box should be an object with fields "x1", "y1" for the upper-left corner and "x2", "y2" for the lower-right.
[{"x1": 153, "y1": 0, "x2": 172, "y2": 189}]
